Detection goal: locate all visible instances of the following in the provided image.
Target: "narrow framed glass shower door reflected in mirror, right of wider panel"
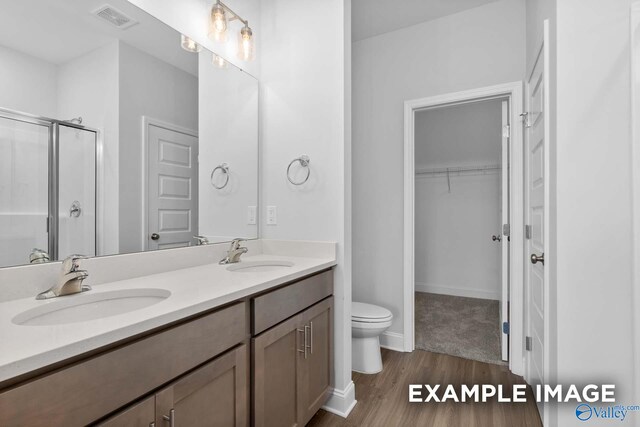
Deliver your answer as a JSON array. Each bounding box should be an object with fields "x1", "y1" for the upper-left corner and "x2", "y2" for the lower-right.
[{"x1": 56, "y1": 124, "x2": 97, "y2": 259}]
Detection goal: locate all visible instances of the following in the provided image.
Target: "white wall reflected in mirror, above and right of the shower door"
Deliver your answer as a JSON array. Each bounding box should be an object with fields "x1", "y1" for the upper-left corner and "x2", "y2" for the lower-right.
[{"x1": 56, "y1": 41, "x2": 119, "y2": 254}]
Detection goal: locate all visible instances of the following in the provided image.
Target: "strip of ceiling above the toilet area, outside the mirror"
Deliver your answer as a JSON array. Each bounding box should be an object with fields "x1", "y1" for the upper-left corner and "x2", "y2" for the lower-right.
[{"x1": 351, "y1": 0, "x2": 497, "y2": 42}]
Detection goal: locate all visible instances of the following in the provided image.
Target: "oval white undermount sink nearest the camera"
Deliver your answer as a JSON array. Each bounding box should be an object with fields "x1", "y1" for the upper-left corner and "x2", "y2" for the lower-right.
[{"x1": 12, "y1": 288, "x2": 171, "y2": 326}]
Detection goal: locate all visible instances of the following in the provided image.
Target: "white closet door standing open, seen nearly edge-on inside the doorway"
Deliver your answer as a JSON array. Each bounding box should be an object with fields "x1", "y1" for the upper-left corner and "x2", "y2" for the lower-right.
[{"x1": 499, "y1": 101, "x2": 511, "y2": 361}]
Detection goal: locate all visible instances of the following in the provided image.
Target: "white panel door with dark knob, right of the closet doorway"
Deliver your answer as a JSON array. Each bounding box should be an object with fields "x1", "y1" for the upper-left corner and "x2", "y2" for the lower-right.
[{"x1": 525, "y1": 24, "x2": 549, "y2": 419}]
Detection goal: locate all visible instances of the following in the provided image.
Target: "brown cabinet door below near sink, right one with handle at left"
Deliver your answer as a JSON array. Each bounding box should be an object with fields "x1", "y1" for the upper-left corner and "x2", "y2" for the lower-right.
[{"x1": 156, "y1": 345, "x2": 249, "y2": 427}]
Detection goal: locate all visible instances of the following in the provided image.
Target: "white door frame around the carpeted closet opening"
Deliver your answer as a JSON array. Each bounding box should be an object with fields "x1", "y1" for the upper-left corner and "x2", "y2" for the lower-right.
[{"x1": 403, "y1": 81, "x2": 524, "y2": 375}]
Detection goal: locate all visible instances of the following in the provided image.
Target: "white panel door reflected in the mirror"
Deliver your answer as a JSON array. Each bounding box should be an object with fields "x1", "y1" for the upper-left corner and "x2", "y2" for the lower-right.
[{"x1": 147, "y1": 124, "x2": 198, "y2": 250}]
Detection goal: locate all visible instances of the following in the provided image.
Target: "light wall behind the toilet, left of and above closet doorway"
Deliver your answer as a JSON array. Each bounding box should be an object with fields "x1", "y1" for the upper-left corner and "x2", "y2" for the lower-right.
[{"x1": 353, "y1": 0, "x2": 525, "y2": 334}]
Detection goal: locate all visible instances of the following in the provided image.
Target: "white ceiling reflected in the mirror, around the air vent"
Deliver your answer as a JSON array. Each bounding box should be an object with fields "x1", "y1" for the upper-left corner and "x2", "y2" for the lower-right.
[{"x1": 0, "y1": 0, "x2": 197, "y2": 74}]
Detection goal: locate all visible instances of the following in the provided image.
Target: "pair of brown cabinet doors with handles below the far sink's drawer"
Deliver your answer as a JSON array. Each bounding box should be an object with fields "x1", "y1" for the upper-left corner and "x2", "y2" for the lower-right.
[{"x1": 252, "y1": 297, "x2": 333, "y2": 427}]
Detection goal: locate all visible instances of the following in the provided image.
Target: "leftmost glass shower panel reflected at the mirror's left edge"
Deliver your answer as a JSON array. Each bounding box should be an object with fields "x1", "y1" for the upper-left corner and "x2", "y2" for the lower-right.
[{"x1": 0, "y1": 116, "x2": 51, "y2": 267}]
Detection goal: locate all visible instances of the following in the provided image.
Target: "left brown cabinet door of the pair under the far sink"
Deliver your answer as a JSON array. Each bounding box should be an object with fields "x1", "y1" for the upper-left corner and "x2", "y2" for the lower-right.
[{"x1": 253, "y1": 314, "x2": 304, "y2": 427}]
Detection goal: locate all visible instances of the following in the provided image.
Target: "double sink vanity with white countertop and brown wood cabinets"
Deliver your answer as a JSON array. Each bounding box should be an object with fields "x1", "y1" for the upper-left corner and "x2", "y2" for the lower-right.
[{"x1": 0, "y1": 241, "x2": 335, "y2": 427}]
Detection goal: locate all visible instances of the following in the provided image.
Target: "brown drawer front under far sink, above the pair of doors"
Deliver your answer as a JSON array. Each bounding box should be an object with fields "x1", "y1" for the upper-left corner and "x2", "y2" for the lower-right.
[{"x1": 251, "y1": 270, "x2": 333, "y2": 335}]
